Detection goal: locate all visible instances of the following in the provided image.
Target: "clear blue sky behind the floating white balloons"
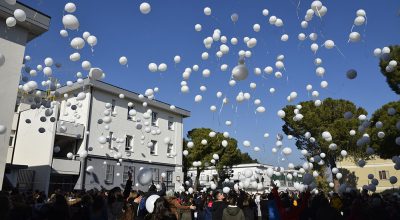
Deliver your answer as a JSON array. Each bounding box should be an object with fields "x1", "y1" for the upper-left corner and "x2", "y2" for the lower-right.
[{"x1": 22, "y1": 0, "x2": 400, "y2": 165}]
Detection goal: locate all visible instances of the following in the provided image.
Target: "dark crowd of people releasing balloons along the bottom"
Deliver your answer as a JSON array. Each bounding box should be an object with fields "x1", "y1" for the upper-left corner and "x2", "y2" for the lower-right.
[{"x1": 0, "y1": 175, "x2": 400, "y2": 220}]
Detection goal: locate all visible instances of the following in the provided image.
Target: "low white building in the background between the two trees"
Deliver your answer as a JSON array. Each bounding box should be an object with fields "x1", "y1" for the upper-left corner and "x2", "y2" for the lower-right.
[{"x1": 188, "y1": 163, "x2": 301, "y2": 192}]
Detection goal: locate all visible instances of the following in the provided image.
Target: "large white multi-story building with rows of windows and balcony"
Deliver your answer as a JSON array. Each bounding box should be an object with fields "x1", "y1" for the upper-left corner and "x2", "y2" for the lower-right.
[{"x1": 7, "y1": 79, "x2": 190, "y2": 192}]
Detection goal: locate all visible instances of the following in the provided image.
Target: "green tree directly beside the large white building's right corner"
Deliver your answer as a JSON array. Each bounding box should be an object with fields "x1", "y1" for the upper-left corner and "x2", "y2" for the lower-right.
[{"x1": 183, "y1": 128, "x2": 256, "y2": 188}]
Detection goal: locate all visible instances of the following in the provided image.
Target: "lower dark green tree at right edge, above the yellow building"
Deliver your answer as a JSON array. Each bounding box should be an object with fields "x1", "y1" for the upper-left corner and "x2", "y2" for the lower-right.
[{"x1": 368, "y1": 102, "x2": 400, "y2": 159}]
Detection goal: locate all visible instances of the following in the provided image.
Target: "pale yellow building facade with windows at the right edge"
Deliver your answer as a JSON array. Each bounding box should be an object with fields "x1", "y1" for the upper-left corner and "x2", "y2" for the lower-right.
[{"x1": 337, "y1": 158, "x2": 400, "y2": 192}]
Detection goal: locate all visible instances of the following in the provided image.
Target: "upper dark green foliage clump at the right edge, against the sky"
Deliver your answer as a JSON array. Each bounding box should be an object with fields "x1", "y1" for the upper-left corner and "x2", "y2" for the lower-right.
[{"x1": 379, "y1": 45, "x2": 400, "y2": 95}]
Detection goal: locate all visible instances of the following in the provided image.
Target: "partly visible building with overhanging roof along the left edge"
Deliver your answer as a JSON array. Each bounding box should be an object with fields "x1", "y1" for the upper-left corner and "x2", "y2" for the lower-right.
[{"x1": 0, "y1": 1, "x2": 50, "y2": 189}]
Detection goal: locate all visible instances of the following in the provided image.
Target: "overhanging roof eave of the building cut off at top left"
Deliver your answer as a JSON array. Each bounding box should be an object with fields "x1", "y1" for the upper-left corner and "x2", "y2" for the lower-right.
[{"x1": 0, "y1": 1, "x2": 50, "y2": 42}]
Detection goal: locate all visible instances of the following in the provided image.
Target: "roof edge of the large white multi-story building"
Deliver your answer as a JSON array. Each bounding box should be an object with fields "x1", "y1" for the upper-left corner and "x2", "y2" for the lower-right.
[{"x1": 57, "y1": 78, "x2": 190, "y2": 118}]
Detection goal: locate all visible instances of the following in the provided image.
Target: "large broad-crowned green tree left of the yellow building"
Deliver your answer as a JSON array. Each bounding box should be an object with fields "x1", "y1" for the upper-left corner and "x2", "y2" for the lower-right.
[{"x1": 282, "y1": 98, "x2": 367, "y2": 169}]
